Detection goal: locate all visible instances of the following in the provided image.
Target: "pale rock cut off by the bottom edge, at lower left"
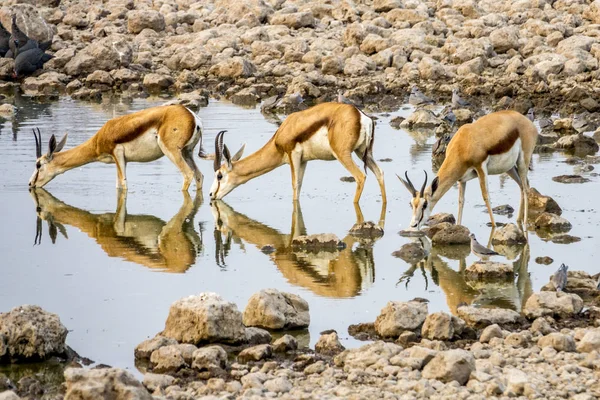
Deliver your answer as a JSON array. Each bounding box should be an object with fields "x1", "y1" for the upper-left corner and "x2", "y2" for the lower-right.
[{"x1": 65, "y1": 368, "x2": 152, "y2": 400}]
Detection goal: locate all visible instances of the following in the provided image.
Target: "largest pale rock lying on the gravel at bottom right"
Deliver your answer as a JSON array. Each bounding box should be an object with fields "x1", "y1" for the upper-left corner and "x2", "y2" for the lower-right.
[{"x1": 423, "y1": 349, "x2": 475, "y2": 385}]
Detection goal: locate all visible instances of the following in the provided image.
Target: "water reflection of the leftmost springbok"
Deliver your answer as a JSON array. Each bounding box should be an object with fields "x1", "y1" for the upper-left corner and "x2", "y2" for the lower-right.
[{"x1": 30, "y1": 189, "x2": 203, "y2": 273}]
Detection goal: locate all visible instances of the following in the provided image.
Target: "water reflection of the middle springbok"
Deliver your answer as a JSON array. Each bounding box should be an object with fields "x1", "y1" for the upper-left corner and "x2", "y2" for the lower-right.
[{"x1": 211, "y1": 201, "x2": 382, "y2": 298}]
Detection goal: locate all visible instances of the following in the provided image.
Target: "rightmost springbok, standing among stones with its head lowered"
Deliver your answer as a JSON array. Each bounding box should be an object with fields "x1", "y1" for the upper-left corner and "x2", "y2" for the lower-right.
[{"x1": 398, "y1": 110, "x2": 538, "y2": 229}]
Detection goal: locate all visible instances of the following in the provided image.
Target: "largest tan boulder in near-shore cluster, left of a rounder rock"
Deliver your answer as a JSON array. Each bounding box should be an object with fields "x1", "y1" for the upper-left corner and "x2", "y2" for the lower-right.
[{"x1": 162, "y1": 293, "x2": 246, "y2": 344}]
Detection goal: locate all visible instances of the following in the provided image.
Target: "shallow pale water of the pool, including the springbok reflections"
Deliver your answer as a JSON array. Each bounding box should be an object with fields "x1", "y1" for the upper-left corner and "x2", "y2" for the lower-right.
[{"x1": 0, "y1": 94, "x2": 600, "y2": 376}]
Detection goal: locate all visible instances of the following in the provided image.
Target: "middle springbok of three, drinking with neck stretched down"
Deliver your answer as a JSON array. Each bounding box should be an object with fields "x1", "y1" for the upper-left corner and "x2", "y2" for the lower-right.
[{"x1": 210, "y1": 103, "x2": 387, "y2": 203}]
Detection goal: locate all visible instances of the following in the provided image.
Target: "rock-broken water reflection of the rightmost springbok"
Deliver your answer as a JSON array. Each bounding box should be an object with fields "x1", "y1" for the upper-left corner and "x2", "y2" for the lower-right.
[{"x1": 399, "y1": 245, "x2": 532, "y2": 315}]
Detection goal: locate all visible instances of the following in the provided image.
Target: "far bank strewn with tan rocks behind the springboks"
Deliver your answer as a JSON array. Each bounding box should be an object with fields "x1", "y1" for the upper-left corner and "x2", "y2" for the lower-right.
[{"x1": 0, "y1": 0, "x2": 600, "y2": 114}]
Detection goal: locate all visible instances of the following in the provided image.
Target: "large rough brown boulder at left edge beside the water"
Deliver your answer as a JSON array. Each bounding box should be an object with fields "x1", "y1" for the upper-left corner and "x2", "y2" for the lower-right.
[{"x1": 0, "y1": 305, "x2": 68, "y2": 364}]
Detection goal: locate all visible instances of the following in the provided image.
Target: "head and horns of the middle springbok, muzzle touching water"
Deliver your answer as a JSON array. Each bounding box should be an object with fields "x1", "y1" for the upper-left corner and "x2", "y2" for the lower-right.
[{"x1": 209, "y1": 131, "x2": 246, "y2": 200}]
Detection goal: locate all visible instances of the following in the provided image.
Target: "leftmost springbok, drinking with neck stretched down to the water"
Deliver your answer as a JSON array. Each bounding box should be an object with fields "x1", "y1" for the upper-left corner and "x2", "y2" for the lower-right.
[{"x1": 29, "y1": 105, "x2": 204, "y2": 191}]
